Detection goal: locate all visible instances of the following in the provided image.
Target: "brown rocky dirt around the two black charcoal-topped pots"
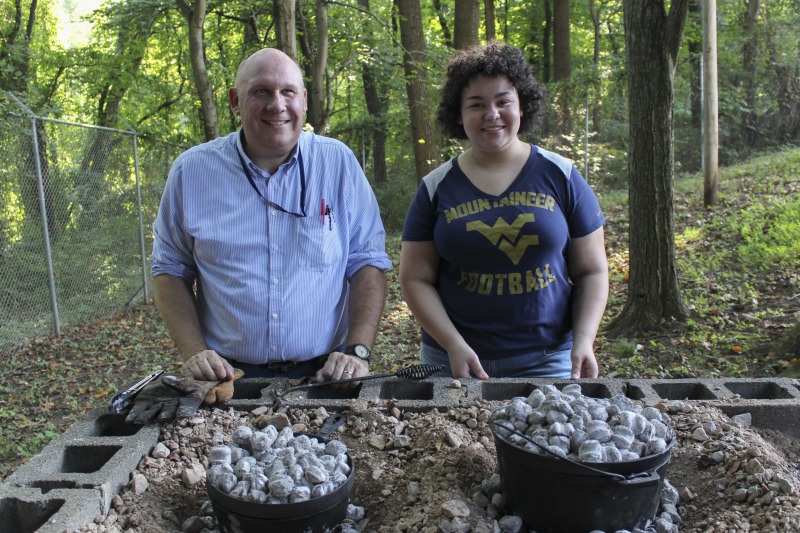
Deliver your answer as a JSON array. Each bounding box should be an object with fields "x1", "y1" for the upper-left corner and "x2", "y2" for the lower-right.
[{"x1": 70, "y1": 386, "x2": 800, "y2": 533}]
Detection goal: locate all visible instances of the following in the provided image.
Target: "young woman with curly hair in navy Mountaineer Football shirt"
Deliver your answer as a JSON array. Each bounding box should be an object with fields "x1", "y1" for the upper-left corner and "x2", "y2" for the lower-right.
[{"x1": 400, "y1": 43, "x2": 608, "y2": 379}]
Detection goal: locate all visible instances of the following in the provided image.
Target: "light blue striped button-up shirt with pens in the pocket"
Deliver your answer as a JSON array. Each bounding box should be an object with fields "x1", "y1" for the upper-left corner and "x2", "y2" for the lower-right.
[{"x1": 152, "y1": 132, "x2": 392, "y2": 364}]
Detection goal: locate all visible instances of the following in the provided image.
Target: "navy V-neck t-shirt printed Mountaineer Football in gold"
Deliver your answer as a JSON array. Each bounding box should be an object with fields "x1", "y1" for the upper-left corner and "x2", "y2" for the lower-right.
[{"x1": 403, "y1": 146, "x2": 605, "y2": 359}]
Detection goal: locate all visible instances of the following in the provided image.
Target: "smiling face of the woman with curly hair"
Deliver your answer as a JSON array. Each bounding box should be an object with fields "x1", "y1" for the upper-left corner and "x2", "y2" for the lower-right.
[{"x1": 460, "y1": 75, "x2": 522, "y2": 152}]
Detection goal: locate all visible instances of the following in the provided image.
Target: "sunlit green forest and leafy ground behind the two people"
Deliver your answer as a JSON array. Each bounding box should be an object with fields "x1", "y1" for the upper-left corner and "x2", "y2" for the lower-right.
[{"x1": 0, "y1": 0, "x2": 800, "y2": 478}]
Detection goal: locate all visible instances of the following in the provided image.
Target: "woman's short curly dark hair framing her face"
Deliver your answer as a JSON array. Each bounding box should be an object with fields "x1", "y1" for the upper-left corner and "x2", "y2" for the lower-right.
[{"x1": 436, "y1": 41, "x2": 546, "y2": 139}]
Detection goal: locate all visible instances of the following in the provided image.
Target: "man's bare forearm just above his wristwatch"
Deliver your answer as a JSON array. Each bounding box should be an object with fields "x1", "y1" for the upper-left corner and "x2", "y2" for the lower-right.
[{"x1": 347, "y1": 266, "x2": 386, "y2": 347}]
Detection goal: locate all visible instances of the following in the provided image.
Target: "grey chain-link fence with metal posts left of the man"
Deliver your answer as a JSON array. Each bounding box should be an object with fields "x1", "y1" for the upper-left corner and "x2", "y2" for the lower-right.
[{"x1": 0, "y1": 98, "x2": 177, "y2": 357}]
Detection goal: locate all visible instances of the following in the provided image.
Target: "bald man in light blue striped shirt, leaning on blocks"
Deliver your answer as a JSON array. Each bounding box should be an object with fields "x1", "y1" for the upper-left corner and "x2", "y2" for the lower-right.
[{"x1": 152, "y1": 48, "x2": 392, "y2": 381}]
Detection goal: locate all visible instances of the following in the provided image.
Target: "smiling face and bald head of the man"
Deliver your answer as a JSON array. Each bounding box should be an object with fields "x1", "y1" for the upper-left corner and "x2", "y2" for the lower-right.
[{"x1": 229, "y1": 50, "x2": 306, "y2": 163}]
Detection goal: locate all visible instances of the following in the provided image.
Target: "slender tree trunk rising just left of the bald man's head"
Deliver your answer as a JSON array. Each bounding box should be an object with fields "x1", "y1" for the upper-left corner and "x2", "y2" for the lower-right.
[{"x1": 175, "y1": 0, "x2": 219, "y2": 141}]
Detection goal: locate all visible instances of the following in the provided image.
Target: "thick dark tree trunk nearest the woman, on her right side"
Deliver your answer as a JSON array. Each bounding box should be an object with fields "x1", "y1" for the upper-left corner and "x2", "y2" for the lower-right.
[{"x1": 609, "y1": 0, "x2": 688, "y2": 336}]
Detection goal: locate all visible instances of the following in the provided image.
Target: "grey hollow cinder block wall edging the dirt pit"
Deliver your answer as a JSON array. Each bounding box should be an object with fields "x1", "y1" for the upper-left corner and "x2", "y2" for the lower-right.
[{"x1": 0, "y1": 378, "x2": 800, "y2": 533}]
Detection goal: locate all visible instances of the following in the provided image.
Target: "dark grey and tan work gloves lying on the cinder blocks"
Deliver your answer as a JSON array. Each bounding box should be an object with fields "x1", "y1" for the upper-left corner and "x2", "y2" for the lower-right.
[{"x1": 125, "y1": 369, "x2": 244, "y2": 425}]
